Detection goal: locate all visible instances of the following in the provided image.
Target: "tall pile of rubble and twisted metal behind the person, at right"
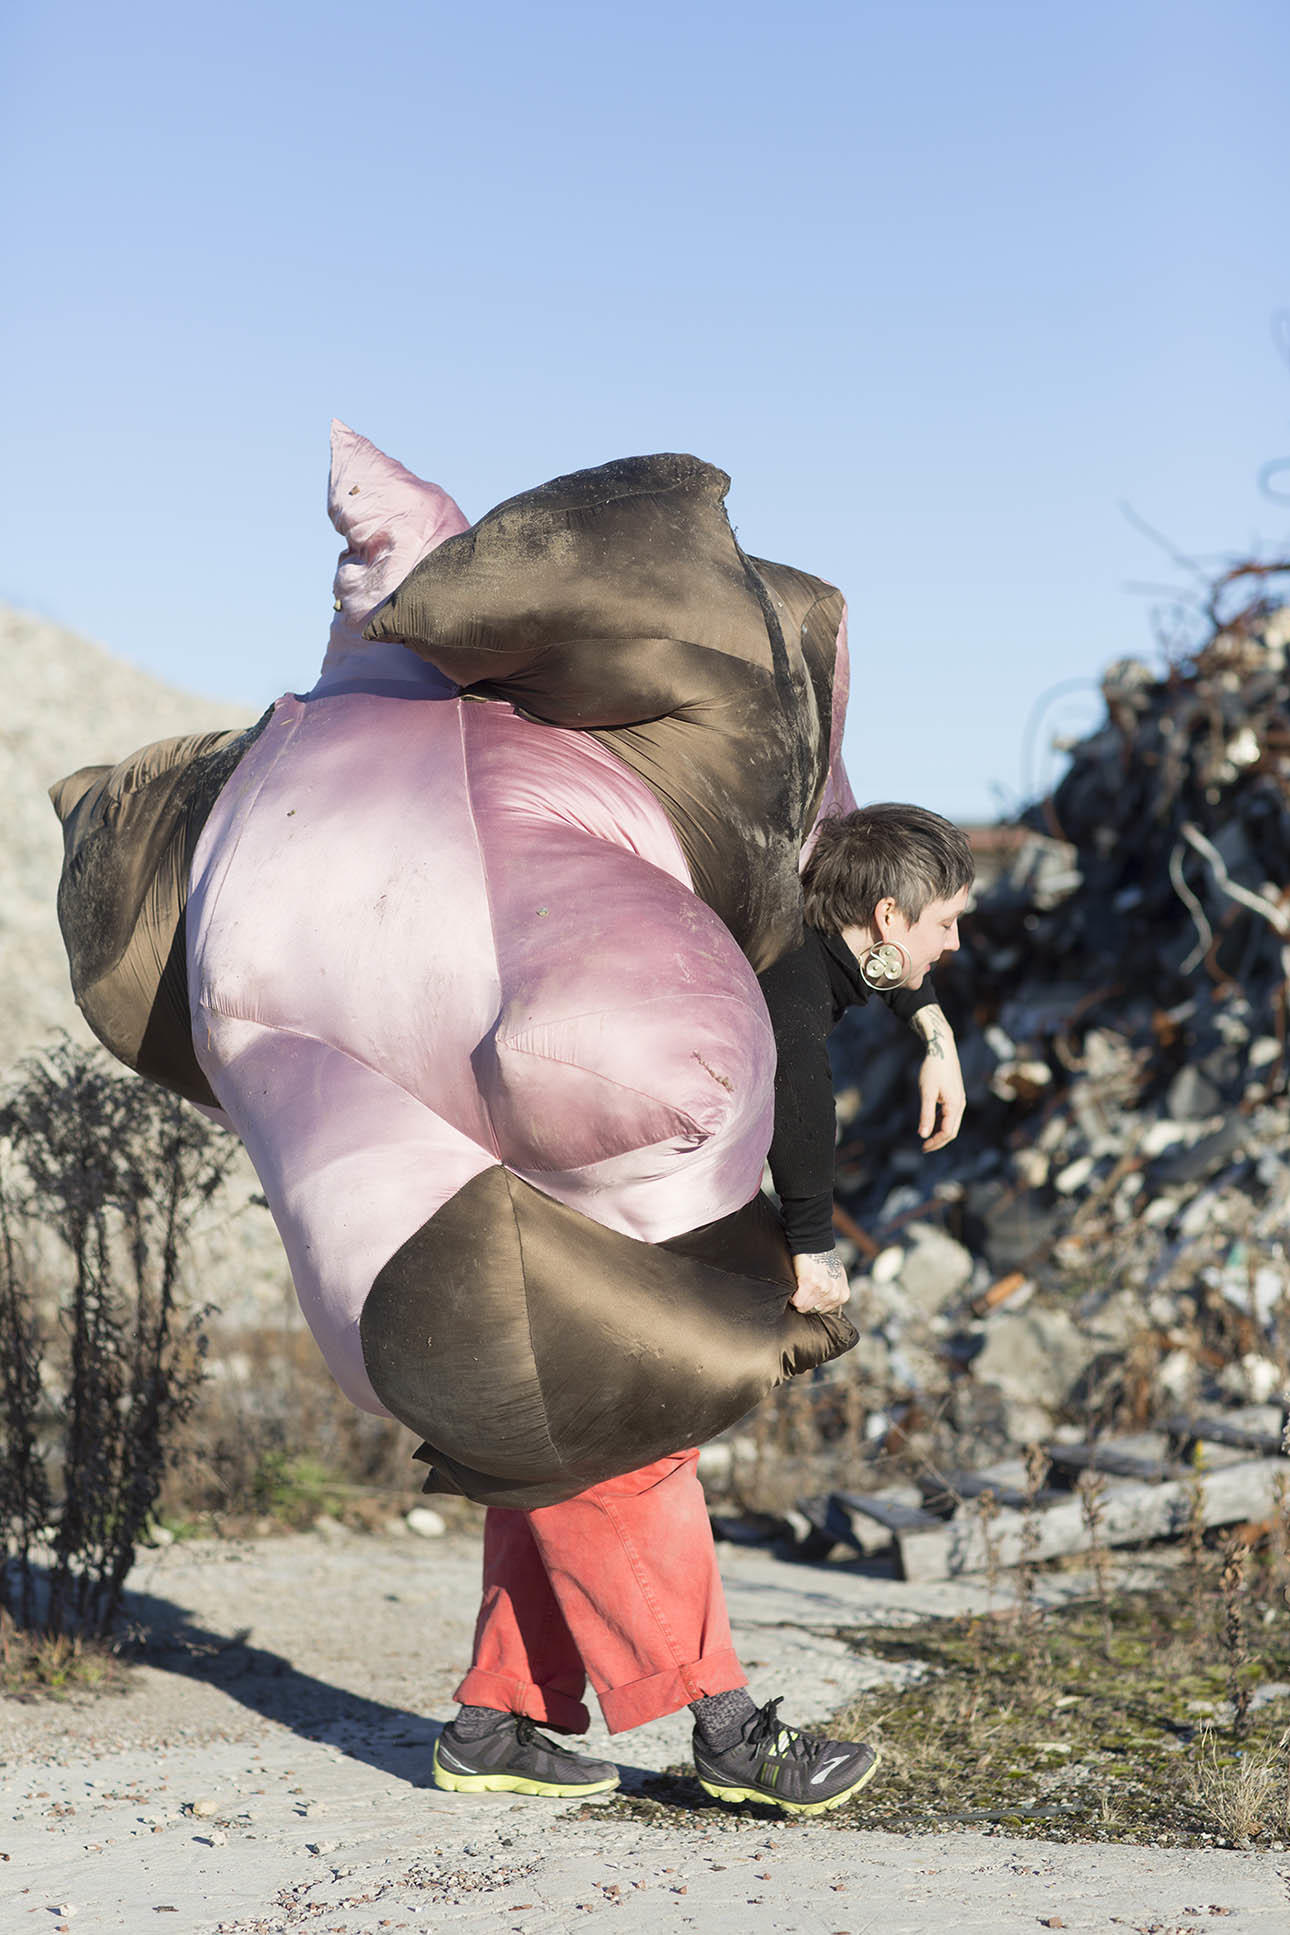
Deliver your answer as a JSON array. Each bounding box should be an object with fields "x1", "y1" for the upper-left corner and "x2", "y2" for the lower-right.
[{"x1": 836, "y1": 606, "x2": 1290, "y2": 1463}]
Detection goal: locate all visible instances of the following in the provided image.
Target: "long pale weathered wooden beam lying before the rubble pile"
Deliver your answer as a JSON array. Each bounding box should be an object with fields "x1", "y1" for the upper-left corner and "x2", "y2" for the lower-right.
[{"x1": 895, "y1": 1459, "x2": 1290, "y2": 1585}]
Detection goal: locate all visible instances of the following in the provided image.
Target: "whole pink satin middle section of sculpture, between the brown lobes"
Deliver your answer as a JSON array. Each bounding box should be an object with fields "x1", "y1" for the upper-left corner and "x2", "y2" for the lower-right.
[{"x1": 188, "y1": 681, "x2": 774, "y2": 1411}]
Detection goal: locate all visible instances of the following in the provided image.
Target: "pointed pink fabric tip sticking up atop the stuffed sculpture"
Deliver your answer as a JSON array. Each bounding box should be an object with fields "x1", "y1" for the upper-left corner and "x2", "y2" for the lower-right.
[{"x1": 323, "y1": 416, "x2": 470, "y2": 668}]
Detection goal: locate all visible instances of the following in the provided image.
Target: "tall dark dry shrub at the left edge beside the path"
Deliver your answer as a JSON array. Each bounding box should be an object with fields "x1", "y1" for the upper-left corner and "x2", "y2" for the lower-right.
[{"x1": 0, "y1": 1039, "x2": 232, "y2": 1637}]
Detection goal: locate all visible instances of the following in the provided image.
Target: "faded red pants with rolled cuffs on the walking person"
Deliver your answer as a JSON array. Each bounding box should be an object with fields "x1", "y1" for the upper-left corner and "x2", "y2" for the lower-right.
[{"x1": 456, "y1": 1451, "x2": 747, "y2": 1734}]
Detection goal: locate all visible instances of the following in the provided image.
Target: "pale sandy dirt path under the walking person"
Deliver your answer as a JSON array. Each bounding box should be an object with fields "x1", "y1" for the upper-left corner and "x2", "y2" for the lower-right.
[{"x1": 0, "y1": 1534, "x2": 1290, "y2": 1935}]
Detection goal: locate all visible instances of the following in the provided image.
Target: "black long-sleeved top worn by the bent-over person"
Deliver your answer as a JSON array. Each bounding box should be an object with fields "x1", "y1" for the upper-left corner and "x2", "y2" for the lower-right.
[{"x1": 758, "y1": 927, "x2": 936, "y2": 1256}]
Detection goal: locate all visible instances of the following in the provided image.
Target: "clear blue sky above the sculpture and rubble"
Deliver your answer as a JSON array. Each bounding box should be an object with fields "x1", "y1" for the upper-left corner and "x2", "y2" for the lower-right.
[{"x1": 0, "y1": 0, "x2": 1290, "y2": 817}]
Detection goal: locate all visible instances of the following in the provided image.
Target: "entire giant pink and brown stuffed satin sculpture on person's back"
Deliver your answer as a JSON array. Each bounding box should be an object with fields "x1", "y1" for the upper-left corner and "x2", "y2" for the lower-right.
[{"x1": 54, "y1": 426, "x2": 855, "y2": 1507}]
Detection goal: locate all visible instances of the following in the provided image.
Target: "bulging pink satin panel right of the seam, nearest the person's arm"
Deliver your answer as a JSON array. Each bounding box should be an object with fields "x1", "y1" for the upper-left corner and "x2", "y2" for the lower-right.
[{"x1": 462, "y1": 702, "x2": 774, "y2": 1242}]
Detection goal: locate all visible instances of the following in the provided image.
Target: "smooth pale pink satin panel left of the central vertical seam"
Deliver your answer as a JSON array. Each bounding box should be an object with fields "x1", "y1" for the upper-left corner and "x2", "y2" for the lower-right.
[{"x1": 188, "y1": 693, "x2": 499, "y2": 1155}]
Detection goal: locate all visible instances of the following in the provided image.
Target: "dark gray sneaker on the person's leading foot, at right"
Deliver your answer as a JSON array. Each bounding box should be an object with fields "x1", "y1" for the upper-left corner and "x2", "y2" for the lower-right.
[{"x1": 694, "y1": 1699, "x2": 878, "y2": 1813}]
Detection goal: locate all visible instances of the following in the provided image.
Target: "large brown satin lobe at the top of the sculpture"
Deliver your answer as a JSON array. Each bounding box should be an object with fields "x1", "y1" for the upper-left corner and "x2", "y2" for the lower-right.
[{"x1": 366, "y1": 455, "x2": 841, "y2": 973}]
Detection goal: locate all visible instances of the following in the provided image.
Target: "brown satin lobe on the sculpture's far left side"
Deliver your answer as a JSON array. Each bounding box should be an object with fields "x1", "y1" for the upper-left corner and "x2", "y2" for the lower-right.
[{"x1": 50, "y1": 714, "x2": 269, "y2": 1107}]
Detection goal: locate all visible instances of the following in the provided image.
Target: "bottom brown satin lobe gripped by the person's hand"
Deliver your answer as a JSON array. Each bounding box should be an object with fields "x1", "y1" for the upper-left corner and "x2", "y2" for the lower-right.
[{"x1": 360, "y1": 1169, "x2": 857, "y2": 1511}]
